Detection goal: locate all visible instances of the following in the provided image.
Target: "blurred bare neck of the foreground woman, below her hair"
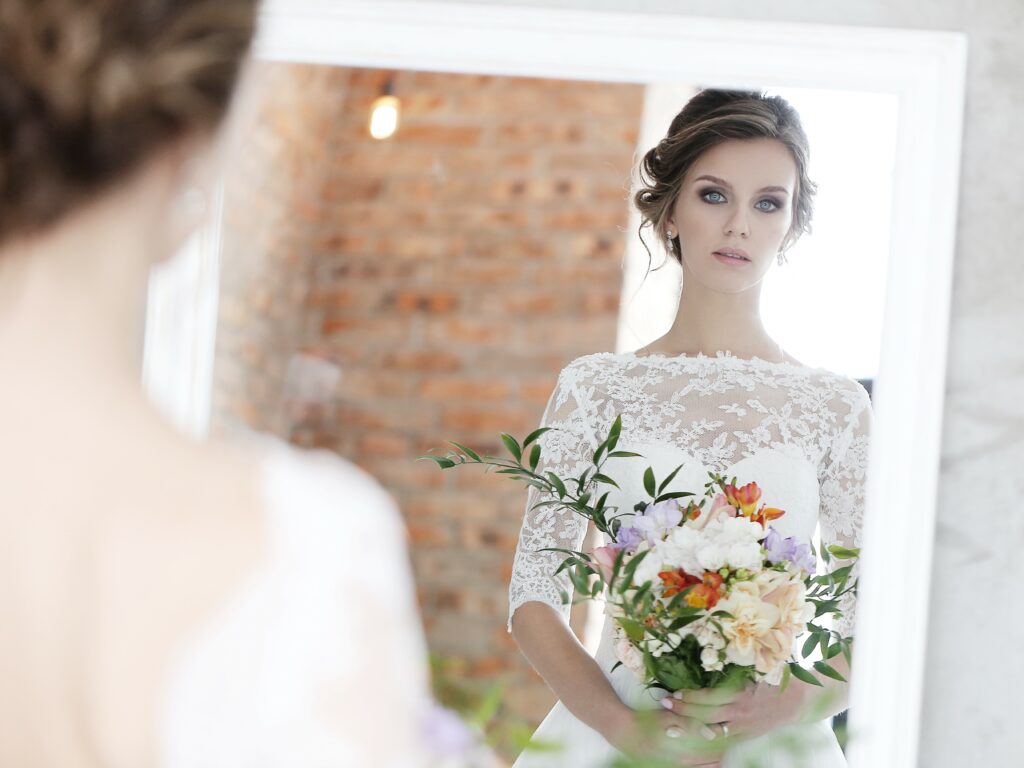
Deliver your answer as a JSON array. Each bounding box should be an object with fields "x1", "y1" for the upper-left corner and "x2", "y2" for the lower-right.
[{"x1": 0, "y1": 174, "x2": 167, "y2": 417}]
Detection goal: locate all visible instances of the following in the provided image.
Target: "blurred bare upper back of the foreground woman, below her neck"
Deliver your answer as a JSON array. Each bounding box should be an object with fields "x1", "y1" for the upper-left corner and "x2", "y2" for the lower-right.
[{"x1": 0, "y1": 409, "x2": 265, "y2": 768}]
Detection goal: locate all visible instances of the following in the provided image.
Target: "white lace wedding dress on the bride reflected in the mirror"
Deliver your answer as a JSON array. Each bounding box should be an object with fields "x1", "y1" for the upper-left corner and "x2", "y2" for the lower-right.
[{"x1": 508, "y1": 352, "x2": 871, "y2": 768}]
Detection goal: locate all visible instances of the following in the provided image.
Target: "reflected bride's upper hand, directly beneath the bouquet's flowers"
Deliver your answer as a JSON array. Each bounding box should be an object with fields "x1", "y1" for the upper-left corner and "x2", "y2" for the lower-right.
[{"x1": 667, "y1": 683, "x2": 806, "y2": 740}]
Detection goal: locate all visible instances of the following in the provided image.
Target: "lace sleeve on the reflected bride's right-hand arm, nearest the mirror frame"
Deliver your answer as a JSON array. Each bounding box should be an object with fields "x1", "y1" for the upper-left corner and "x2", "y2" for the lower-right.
[{"x1": 819, "y1": 382, "x2": 872, "y2": 637}]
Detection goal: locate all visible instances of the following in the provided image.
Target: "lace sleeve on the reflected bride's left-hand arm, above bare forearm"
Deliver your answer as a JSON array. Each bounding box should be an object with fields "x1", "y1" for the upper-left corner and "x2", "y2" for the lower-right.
[{"x1": 508, "y1": 364, "x2": 597, "y2": 632}]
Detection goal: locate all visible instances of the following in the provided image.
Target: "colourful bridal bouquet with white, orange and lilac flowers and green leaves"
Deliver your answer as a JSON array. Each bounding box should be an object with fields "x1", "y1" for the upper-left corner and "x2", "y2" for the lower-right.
[{"x1": 420, "y1": 417, "x2": 859, "y2": 691}]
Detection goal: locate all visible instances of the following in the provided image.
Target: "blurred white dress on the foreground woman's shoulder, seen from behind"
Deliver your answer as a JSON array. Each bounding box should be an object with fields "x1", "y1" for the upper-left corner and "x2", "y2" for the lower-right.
[{"x1": 159, "y1": 438, "x2": 429, "y2": 768}]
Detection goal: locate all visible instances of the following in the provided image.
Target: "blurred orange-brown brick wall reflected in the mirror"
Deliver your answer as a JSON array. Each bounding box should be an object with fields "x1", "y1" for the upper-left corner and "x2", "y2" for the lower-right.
[{"x1": 214, "y1": 65, "x2": 643, "y2": 737}]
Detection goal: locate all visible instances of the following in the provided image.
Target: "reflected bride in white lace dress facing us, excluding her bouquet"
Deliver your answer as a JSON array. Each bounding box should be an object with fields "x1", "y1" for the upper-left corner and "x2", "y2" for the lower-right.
[{"x1": 509, "y1": 89, "x2": 871, "y2": 768}]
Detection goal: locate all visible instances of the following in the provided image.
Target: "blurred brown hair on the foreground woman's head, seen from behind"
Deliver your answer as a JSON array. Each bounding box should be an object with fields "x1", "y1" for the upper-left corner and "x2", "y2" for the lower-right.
[{"x1": 0, "y1": 0, "x2": 257, "y2": 243}]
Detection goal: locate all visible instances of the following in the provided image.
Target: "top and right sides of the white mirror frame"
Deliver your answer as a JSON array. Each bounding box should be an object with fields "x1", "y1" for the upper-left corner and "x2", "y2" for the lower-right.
[{"x1": 254, "y1": 0, "x2": 967, "y2": 768}]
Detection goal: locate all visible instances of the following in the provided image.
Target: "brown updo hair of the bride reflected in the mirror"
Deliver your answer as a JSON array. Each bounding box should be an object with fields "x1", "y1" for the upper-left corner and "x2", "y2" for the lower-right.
[{"x1": 633, "y1": 88, "x2": 817, "y2": 270}]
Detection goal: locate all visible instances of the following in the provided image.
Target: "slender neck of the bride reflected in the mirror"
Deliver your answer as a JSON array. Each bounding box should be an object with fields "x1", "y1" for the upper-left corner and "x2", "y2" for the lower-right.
[{"x1": 657, "y1": 257, "x2": 779, "y2": 359}]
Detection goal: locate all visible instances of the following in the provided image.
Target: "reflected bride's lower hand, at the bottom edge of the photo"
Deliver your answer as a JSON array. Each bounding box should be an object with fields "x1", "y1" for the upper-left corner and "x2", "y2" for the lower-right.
[{"x1": 602, "y1": 706, "x2": 725, "y2": 768}]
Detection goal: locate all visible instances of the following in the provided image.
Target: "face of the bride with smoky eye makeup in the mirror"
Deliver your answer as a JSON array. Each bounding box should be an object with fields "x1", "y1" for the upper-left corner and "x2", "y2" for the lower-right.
[{"x1": 667, "y1": 138, "x2": 797, "y2": 293}]
